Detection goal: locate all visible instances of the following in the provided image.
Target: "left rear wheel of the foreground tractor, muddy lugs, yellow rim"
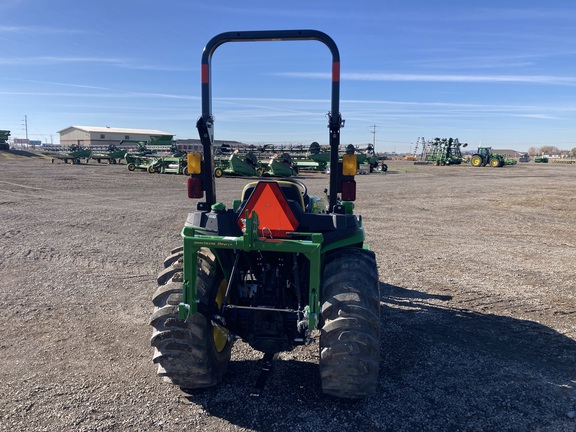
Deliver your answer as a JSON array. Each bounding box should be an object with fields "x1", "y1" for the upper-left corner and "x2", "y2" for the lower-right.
[{"x1": 150, "y1": 249, "x2": 233, "y2": 390}]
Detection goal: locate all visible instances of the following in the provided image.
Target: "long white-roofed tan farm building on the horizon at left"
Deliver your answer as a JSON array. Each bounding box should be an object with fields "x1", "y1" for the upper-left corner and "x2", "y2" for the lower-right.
[{"x1": 58, "y1": 126, "x2": 174, "y2": 147}]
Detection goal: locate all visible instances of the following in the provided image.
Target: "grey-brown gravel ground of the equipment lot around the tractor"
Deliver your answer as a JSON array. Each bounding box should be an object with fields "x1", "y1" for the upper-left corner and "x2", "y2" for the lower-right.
[{"x1": 0, "y1": 153, "x2": 576, "y2": 431}]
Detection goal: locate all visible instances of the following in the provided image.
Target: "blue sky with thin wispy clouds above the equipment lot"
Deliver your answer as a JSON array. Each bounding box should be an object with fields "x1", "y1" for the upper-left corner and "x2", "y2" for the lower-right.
[{"x1": 0, "y1": 0, "x2": 576, "y2": 152}]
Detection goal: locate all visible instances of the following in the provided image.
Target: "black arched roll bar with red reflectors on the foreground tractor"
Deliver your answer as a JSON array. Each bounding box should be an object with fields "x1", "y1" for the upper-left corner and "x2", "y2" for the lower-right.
[{"x1": 196, "y1": 30, "x2": 343, "y2": 211}]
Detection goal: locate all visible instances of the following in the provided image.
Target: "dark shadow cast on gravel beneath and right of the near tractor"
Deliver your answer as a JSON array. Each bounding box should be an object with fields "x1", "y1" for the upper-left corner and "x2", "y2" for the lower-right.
[{"x1": 181, "y1": 284, "x2": 576, "y2": 431}]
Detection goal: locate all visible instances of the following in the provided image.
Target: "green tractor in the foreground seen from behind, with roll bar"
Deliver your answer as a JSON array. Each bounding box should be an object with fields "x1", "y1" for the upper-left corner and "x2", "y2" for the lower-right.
[{"x1": 150, "y1": 30, "x2": 380, "y2": 399}]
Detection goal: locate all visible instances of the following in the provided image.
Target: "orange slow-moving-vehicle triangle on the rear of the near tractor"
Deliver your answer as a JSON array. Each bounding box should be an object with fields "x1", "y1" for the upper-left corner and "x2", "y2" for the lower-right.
[{"x1": 238, "y1": 182, "x2": 298, "y2": 237}]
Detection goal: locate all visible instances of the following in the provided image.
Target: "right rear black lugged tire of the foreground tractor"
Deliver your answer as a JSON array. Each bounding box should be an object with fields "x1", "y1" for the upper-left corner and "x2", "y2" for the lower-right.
[{"x1": 320, "y1": 248, "x2": 380, "y2": 399}]
